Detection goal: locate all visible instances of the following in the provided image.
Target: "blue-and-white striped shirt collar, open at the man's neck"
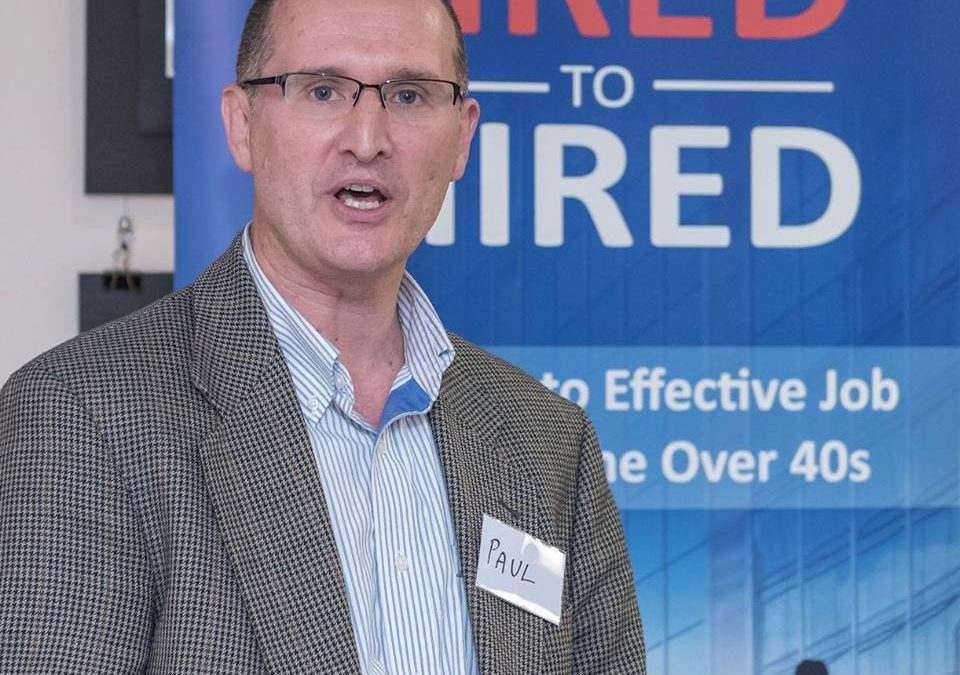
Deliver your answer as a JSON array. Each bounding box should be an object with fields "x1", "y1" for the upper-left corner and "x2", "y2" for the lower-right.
[{"x1": 243, "y1": 223, "x2": 455, "y2": 417}]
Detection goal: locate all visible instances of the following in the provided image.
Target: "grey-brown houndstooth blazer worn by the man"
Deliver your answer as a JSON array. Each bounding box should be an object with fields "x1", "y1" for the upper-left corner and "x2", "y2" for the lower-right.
[{"x1": 0, "y1": 240, "x2": 646, "y2": 675}]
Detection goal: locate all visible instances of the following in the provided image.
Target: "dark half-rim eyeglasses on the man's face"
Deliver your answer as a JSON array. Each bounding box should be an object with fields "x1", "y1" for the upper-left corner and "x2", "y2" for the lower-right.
[{"x1": 240, "y1": 73, "x2": 465, "y2": 123}]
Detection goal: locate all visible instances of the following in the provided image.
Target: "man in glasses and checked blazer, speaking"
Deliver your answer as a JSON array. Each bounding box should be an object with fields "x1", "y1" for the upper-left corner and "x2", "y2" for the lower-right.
[{"x1": 0, "y1": 0, "x2": 645, "y2": 675}]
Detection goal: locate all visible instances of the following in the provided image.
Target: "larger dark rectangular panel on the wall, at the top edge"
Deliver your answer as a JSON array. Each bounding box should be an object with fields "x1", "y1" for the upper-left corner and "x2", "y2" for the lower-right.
[{"x1": 86, "y1": 0, "x2": 173, "y2": 194}]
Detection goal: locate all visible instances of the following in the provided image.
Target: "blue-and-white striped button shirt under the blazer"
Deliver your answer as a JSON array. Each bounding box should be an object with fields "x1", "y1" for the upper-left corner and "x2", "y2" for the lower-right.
[{"x1": 243, "y1": 226, "x2": 478, "y2": 675}]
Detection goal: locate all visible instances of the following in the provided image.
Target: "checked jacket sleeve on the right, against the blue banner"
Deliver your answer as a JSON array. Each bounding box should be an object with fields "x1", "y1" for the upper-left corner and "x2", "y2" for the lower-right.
[{"x1": 568, "y1": 413, "x2": 647, "y2": 675}]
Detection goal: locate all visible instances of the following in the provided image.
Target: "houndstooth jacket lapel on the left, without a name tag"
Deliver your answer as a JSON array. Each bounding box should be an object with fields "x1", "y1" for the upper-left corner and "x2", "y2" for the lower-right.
[{"x1": 192, "y1": 242, "x2": 360, "y2": 675}]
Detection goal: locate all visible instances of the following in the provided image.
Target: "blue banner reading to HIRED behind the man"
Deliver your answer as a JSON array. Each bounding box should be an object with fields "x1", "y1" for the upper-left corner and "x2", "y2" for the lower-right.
[{"x1": 175, "y1": 0, "x2": 960, "y2": 675}]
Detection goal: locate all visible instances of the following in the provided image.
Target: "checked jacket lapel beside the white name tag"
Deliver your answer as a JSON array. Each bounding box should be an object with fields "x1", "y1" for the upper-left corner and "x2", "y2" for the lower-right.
[{"x1": 430, "y1": 355, "x2": 547, "y2": 675}]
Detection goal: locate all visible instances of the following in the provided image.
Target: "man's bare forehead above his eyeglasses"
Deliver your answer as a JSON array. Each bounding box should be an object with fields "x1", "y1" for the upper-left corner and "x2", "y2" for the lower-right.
[{"x1": 267, "y1": 0, "x2": 455, "y2": 79}]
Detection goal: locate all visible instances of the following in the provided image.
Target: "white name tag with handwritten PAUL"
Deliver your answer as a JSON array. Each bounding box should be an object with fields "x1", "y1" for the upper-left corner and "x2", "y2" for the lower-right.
[{"x1": 477, "y1": 514, "x2": 567, "y2": 625}]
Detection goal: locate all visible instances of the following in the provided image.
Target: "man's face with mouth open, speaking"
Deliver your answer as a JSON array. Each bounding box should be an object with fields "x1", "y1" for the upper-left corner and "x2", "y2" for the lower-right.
[{"x1": 223, "y1": 0, "x2": 479, "y2": 285}]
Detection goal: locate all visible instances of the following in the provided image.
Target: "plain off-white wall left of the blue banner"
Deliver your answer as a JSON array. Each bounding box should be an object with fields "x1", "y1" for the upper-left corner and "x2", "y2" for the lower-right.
[{"x1": 0, "y1": 0, "x2": 173, "y2": 383}]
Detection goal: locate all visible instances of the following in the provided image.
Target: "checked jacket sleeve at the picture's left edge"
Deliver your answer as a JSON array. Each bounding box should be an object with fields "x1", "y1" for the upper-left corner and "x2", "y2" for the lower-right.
[{"x1": 0, "y1": 363, "x2": 153, "y2": 673}]
